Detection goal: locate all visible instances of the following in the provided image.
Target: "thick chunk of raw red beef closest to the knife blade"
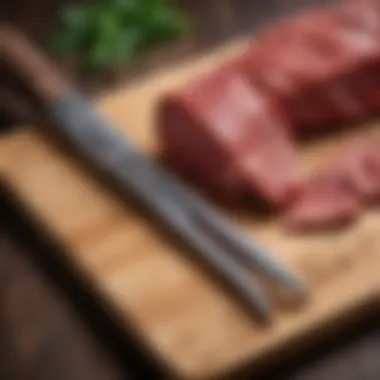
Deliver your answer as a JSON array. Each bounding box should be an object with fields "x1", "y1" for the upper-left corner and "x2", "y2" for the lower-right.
[{"x1": 157, "y1": 67, "x2": 299, "y2": 205}]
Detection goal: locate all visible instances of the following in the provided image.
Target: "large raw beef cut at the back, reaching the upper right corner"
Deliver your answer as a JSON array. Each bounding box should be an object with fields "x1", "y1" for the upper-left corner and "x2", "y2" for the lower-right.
[{"x1": 240, "y1": 0, "x2": 380, "y2": 131}]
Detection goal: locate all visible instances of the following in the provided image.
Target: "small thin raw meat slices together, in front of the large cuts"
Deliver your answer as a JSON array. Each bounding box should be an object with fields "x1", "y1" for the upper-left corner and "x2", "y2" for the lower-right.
[{"x1": 285, "y1": 139, "x2": 380, "y2": 230}]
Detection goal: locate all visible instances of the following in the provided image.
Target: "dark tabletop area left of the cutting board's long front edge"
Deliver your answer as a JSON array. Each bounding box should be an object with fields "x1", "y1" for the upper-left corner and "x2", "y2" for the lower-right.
[{"x1": 0, "y1": 191, "x2": 174, "y2": 380}]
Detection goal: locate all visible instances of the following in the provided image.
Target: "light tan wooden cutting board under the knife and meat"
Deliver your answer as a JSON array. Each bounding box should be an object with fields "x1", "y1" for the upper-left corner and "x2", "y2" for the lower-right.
[{"x1": 0, "y1": 42, "x2": 380, "y2": 379}]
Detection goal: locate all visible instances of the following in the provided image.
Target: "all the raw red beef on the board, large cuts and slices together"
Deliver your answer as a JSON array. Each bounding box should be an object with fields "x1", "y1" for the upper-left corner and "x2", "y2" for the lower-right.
[{"x1": 157, "y1": 0, "x2": 380, "y2": 228}]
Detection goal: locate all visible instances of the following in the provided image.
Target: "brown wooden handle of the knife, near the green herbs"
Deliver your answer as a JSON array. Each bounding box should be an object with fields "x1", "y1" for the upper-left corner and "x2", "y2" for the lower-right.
[{"x1": 0, "y1": 26, "x2": 71, "y2": 103}]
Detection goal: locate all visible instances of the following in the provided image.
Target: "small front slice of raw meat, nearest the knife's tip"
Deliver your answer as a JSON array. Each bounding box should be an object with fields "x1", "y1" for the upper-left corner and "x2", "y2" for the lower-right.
[{"x1": 284, "y1": 172, "x2": 360, "y2": 231}]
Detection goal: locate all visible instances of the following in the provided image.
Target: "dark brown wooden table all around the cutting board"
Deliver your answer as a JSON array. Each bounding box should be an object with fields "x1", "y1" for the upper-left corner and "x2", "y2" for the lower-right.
[{"x1": 0, "y1": 0, "x2": 380, "y2": 380}]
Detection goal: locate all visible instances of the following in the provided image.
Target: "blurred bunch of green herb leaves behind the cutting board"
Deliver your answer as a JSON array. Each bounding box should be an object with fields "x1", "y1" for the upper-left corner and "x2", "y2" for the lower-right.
[{"x1": 48, "y1": 0, "x2": 189, "y2": 70}]
